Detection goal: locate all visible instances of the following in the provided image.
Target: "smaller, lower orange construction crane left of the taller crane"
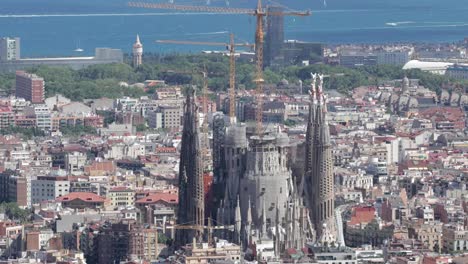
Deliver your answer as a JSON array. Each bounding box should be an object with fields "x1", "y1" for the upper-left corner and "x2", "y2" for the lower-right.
[{"x1": 156, "y1": 34, "x2": 255, "y2": 123}]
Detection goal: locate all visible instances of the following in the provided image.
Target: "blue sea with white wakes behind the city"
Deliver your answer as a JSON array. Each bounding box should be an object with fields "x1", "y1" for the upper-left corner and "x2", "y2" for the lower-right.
[{"x1": 0, "y1": 0, "x2": 468, "y2": 57}]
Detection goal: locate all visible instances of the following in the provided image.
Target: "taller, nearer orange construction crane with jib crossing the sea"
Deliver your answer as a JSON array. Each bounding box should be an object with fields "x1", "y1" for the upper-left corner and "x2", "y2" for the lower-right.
[{"x1": 129, "y1": 0, "x2": 310, "y2": 136}]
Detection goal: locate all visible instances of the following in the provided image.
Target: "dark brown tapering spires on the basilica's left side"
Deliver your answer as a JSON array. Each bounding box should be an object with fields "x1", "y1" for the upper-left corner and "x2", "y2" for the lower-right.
[{"x1": 176, "y1": 89, "x2": 205, "y2": 245}]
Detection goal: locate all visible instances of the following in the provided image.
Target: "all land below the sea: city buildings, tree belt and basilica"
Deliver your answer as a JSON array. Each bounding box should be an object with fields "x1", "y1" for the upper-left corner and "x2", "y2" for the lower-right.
[{"x1": 0, "y1": 1, "x2": 468, "y2": 264}]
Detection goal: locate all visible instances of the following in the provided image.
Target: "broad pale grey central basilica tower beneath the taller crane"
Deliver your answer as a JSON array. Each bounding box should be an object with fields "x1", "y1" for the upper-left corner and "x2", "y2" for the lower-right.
[{"x1": 239, "y1": 132, "x2": 292, "y2": 236}]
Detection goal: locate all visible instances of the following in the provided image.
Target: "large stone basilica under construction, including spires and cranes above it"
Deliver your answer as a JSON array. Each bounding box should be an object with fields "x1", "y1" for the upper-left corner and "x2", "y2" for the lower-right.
[{"x1": 129, "y1": 0, "x2": 335, "y2": 263}]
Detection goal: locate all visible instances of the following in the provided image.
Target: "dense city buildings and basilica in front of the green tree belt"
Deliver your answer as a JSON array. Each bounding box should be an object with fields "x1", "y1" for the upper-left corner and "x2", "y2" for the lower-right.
[{"x1": 0, "y1": 57, "x2": 468, "y2": 264}]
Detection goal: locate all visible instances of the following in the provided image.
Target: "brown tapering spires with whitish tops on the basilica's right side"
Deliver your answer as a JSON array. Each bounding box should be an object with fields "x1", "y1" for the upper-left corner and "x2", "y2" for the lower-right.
[{"x1": 301, "y1": 74, "x2": 335, "y2": 240}]
